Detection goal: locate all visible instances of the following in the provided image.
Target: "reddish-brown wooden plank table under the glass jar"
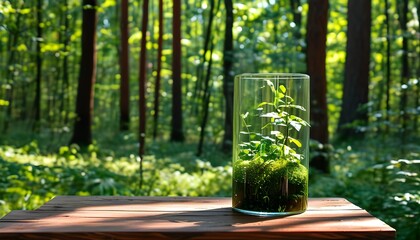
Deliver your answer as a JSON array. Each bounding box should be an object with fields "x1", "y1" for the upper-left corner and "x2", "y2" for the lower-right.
[{"x1": 0, "y1": 196, "x2": 395, "y2": 240}]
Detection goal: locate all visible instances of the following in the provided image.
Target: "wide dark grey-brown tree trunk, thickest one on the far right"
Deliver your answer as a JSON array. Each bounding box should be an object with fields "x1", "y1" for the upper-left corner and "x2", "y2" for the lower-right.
[{"x1": 338, "y1": 0, "x2": 371, "y2": 138}]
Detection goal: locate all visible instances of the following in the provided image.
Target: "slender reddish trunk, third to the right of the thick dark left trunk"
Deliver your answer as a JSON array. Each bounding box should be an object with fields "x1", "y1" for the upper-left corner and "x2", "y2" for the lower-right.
[{"x1": 153, "y1": 0, "x2": 163, "y2": 139}]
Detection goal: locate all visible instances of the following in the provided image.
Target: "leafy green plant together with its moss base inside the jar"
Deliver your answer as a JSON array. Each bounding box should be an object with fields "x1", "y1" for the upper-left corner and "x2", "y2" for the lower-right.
[{"x1": 233, "y1": 80, "x2": 309, "y2": 213}]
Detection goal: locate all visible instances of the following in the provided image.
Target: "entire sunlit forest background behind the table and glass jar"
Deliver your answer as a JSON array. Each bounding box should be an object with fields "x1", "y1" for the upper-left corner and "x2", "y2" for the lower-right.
[{"x1": 0, "y1": 0, "x2": 420, "y2": 239}]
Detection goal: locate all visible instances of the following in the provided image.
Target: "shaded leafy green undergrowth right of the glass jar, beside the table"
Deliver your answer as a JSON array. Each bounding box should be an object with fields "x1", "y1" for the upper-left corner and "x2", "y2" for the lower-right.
[{"x1": 309, "y1": 137, "x2": 420, "y2": 239}]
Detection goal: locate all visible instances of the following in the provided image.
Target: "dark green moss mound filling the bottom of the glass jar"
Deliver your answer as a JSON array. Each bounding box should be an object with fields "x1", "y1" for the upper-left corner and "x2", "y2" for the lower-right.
[{"x1": 233, "y1": 157, "x2": 308, "y2": 212}]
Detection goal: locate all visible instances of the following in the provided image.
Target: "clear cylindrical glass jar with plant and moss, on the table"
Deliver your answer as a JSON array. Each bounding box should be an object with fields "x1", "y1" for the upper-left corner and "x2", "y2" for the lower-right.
[{"x1": 232, "y1": 73, "x2": 309, "y2": 216}]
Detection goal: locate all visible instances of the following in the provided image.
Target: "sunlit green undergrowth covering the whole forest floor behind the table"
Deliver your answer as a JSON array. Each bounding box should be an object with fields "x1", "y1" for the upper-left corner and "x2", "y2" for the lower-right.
[{"x1": 0, "y1": 132, "x2": 420, "y2": 239}]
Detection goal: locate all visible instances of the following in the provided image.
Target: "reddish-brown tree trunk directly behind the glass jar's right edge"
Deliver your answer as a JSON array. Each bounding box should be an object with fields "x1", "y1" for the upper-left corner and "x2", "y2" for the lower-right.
[{"x1": 306, "y1": 0, "x2": 329, "y2": 172}]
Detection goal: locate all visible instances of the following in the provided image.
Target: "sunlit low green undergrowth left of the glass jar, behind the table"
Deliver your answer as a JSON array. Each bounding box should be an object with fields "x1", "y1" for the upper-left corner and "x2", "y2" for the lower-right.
[{"x1": 0, "y1": 142, "x2": 231, "y2": 216}]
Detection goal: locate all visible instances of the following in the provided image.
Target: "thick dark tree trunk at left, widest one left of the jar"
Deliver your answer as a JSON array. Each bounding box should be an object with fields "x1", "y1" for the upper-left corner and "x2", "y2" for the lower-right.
[{"x1": 70, "y1": 0, "x2": 97, "y2": 146}]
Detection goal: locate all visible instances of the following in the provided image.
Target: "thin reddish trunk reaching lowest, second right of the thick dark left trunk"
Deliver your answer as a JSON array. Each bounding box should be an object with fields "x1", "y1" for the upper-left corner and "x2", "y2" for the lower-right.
[{"x1": 139, "y1": 0, "x2": 149, "y2": 156}]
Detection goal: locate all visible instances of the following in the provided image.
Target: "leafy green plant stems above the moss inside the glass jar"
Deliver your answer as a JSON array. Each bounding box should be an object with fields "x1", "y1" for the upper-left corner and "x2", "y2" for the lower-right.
[{"x1": 239, "y1": 80, "x2": 309, "y2": 162}]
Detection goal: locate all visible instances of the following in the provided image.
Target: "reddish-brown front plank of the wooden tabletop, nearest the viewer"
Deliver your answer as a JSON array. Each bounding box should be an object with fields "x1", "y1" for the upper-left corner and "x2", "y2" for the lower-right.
[{"x1": 0, "y1": 213, "x2": 394, "y2": 232}]
